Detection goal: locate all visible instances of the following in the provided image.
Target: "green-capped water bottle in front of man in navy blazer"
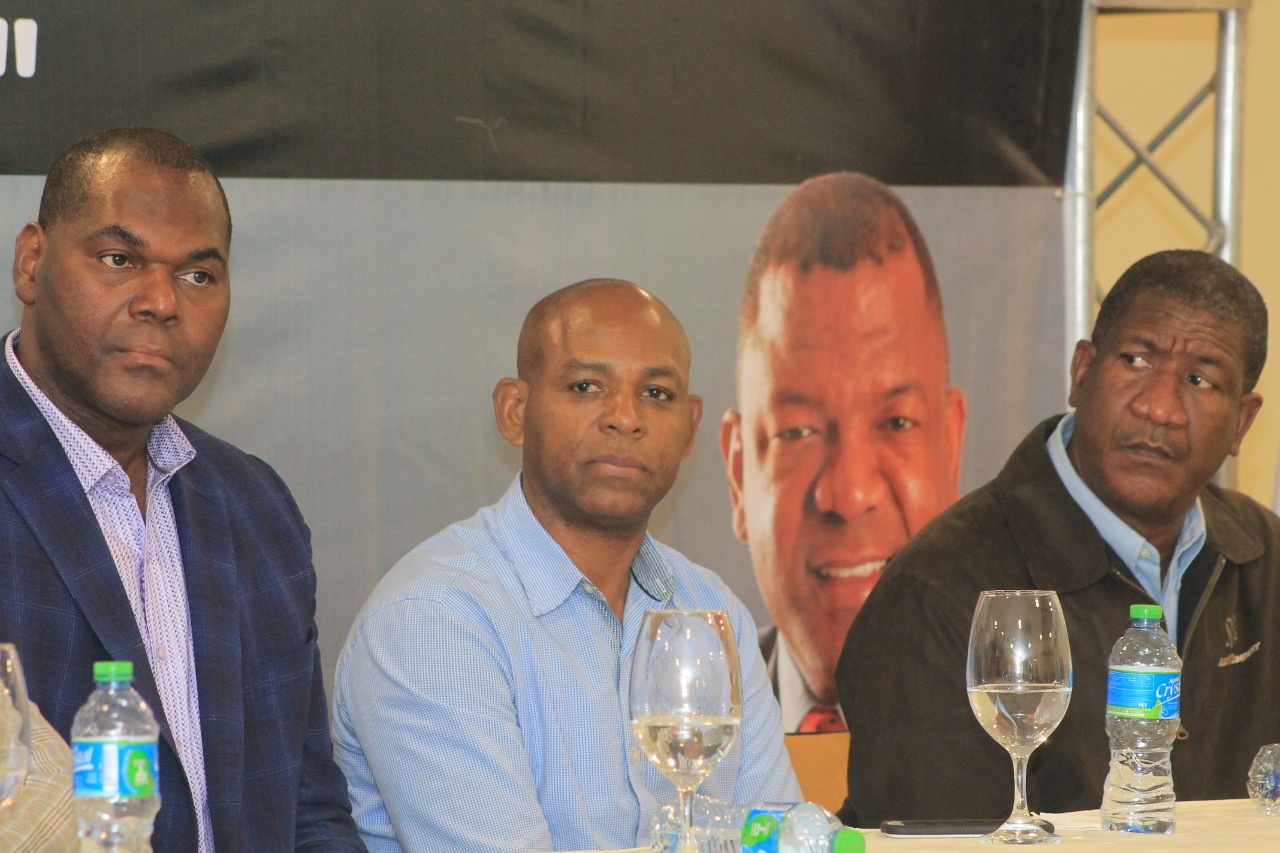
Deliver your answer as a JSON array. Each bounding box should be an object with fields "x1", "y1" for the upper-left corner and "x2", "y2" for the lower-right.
[{"x1": 72, "y1": 661, "x2": 160, "y2": 853}]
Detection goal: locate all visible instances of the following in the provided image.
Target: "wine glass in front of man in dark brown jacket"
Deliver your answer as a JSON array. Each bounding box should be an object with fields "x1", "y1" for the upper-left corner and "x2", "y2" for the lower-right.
[{"x1": 966, "y1": 589, "x2": 1071, "y2": 844}]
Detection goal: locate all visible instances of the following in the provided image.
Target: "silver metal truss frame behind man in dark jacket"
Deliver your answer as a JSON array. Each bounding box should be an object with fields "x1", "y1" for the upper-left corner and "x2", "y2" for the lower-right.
[{"x1": 1064, "y1": 0, "x2": 1252, "y2": 485}]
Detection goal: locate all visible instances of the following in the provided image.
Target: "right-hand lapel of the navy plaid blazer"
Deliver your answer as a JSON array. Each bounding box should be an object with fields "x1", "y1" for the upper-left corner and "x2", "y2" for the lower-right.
[{"x1": 169, "y1": 466, "x2": 244, "y2": 849}]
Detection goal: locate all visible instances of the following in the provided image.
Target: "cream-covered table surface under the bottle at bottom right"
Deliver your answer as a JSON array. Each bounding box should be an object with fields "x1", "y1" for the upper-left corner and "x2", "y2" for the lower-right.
[{"x1": 864, "y1": 799, "x2": 1280, "y2": 853}]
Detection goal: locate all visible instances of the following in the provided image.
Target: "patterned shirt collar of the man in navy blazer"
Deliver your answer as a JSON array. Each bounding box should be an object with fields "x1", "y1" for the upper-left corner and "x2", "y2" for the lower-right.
[{"x1": 4, "y1": 329, "x2": 196, "y2": 492}]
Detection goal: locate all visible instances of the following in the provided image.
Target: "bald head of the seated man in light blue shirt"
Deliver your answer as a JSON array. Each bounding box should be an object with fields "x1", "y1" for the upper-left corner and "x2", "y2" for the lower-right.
[{"x1": 493, "y1": 279, "x2": 703, "y2": 540}]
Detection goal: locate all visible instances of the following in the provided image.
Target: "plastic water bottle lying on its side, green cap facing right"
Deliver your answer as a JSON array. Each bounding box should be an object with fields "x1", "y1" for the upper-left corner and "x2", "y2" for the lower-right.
[{"x1": 652, "y1": 795, "x2": 865, "y2": 853}]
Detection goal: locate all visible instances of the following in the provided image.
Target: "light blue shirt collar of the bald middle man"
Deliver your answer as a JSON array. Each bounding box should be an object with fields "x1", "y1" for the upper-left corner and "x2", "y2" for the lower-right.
[{"x1": 498, "y1": 475, "x2": 676, "y2": 616}]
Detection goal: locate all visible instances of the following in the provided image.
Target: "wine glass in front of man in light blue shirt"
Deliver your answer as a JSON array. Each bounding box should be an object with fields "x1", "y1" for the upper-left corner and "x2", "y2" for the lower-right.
[{"x1": 631, "y1": 610, "x2": 742, "y2": 853}]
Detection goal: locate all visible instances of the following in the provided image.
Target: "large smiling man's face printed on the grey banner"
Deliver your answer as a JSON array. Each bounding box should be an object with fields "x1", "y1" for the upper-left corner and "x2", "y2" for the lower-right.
[{"x1": 722, "y1": 246, "x2": 965, "y2": 702}]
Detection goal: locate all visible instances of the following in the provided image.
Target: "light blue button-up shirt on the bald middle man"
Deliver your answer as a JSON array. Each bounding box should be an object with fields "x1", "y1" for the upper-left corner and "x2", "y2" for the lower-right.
[{"x1": 333, "y1": 476, "x2": 800, "y2": 853}]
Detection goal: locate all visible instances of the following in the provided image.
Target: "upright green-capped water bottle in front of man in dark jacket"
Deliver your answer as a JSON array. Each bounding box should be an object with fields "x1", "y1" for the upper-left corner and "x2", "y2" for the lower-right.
[{"x1": 1102, "y1": 605, "x2": 1183, "y2": 833}]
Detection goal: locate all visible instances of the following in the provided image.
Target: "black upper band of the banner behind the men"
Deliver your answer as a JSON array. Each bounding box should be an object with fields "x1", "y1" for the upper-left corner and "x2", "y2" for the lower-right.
[{"x1": 0, "y1": 0, "x2": 1080, "y2": 186}]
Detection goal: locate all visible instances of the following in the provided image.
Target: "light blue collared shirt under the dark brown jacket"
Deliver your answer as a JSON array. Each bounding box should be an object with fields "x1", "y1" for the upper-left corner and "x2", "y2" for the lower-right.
[{"x1": 1047, "y1": 412, "x2": 1204, "y2": 643}]
